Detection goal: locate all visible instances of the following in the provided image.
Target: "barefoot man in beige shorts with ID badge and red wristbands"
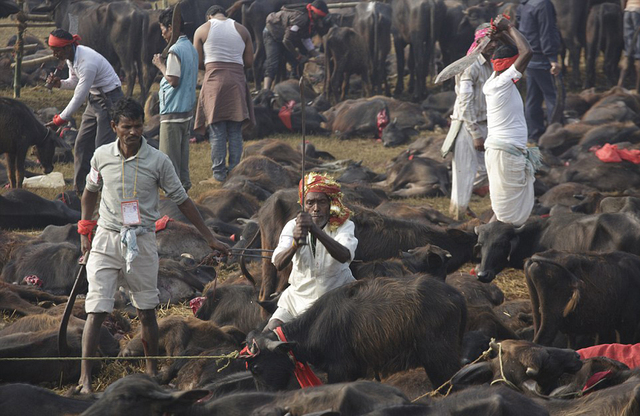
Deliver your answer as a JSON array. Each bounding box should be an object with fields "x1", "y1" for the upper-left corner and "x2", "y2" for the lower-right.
[{"x1": 78, "y1": 99, "x2": 229, "y2": 393}]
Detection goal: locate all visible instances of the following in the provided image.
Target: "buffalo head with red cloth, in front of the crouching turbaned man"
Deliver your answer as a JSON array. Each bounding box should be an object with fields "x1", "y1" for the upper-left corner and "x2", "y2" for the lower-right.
[{"x1": 241, "y1": 331, "x2": 295, "y2": 391}]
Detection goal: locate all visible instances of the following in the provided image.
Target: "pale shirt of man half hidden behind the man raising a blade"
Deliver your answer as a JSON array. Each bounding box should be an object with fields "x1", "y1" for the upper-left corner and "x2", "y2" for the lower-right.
[{"x1": 451, "y1": 54, "x2": 493, "y2": 139}]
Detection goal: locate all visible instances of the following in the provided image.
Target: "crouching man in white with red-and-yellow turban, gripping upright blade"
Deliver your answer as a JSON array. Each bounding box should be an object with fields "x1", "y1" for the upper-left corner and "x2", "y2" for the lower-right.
[{"x1": 265, "y1": 172, "x2": 358, "y2": 331}]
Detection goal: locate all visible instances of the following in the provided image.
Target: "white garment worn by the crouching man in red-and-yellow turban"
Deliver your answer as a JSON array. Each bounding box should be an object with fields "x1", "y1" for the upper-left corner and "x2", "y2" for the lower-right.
[{"x1": 271, "y1": 218, "x2": 358, "y2": 322}]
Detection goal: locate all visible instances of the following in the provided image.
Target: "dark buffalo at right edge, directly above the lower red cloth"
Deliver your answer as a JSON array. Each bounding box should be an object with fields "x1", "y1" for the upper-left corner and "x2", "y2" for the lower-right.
[{"x1": 524, "y1": 250, "x2": 640, "y2": 345}]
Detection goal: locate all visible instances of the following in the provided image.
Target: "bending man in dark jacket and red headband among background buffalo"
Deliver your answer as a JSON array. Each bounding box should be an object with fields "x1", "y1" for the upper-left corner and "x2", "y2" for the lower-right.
[{"x1": 263, "y1": 0, "x2": 329, "y2": 90}]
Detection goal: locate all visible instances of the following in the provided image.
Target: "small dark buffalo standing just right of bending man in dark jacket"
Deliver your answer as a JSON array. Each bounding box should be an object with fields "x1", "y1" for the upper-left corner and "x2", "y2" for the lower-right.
[{"x1": 324, "y1": 27, "x2": 371, "y2": 104}]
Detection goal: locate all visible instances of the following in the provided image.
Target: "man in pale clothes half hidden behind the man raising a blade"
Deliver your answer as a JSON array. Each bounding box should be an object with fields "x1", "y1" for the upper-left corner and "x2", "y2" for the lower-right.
[{"x1": 442, "y1": 23, "x2": 495, "y2": 220}]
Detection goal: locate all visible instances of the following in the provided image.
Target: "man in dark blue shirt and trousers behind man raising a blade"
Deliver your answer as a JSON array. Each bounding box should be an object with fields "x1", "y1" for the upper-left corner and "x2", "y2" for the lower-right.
[{"x1": 517, "y1": 0, "x2": 560, "y2": 143}]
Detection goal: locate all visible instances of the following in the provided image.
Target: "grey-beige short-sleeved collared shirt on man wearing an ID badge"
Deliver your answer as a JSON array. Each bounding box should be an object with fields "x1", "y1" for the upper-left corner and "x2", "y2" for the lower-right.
[{"x1": 86, "y1": 138, "x2": 188, "y2": 232}]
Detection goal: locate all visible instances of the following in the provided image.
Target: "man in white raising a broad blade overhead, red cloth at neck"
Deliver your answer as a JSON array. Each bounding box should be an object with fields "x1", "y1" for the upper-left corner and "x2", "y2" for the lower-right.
[{"x1": 483, "y1": 18, "x2": 540, "y2": 225}]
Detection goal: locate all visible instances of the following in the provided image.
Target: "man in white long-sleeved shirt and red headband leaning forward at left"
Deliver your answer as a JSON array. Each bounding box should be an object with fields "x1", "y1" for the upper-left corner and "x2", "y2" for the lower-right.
[{"x1": 47, "y1": 29, "x2": 123, "y2": 193}]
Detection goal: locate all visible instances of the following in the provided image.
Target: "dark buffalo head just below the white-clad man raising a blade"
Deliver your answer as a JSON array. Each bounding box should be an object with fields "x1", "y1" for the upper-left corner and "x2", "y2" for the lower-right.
[{"x1": 474, "y1": 221, "x2": 521, "y2": 283}]
